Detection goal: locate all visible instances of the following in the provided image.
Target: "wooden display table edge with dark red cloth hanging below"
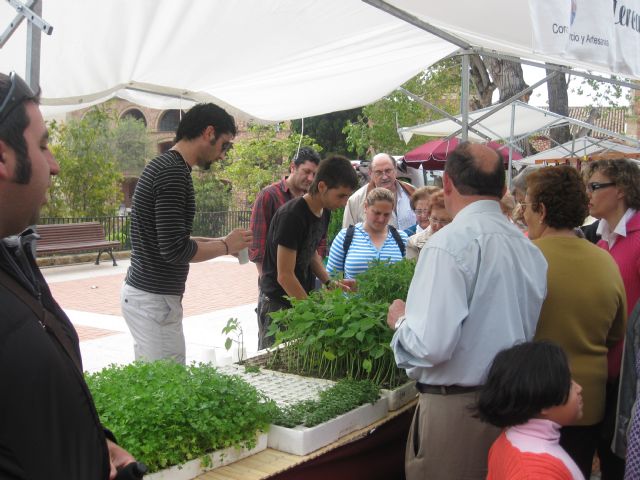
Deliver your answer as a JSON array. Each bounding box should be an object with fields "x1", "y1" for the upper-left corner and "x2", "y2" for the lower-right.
[{"x1": 198, "y1": 399, "x2": 417, "y2": 480}]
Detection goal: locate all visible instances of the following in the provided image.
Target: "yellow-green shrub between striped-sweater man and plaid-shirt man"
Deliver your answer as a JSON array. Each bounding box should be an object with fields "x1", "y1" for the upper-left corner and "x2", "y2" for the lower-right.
[{"x1": 215, "y1": 125, "x2": 322, "y2": 209}]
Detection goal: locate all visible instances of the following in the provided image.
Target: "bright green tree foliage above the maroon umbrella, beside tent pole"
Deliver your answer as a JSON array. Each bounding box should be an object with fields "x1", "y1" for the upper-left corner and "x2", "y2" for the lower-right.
[{"x1": 343, "y1": 57, "x2": 460, "y2": 158}]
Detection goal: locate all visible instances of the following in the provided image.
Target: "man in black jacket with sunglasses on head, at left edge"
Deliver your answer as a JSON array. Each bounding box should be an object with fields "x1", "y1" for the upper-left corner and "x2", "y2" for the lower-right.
[{"x1": 0, "y1": 69, "x2": 134, "y2": 480}]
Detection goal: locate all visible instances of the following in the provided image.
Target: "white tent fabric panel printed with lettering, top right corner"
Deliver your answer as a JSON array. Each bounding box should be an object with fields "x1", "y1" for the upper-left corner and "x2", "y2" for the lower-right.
[{"x1": 387, "y1": 0, "x2": 640, "y2": 79}]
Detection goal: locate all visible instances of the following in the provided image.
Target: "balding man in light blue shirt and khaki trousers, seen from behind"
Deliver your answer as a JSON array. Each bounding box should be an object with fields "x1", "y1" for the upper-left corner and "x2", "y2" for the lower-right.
[{"x1": 387, "y1": 142, "x2": 547, "y2": 480}]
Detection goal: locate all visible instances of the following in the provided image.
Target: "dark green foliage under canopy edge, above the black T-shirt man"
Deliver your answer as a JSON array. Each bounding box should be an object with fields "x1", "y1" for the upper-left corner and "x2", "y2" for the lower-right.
[{"x1": 291, "y1": 108, "x2": 362, "y2": 157}]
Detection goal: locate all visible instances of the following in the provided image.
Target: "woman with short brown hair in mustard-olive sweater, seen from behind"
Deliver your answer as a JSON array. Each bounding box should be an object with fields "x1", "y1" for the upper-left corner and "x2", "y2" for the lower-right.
[{"x1": 522, "y1": 166, "x2": 626, "y2": 478}]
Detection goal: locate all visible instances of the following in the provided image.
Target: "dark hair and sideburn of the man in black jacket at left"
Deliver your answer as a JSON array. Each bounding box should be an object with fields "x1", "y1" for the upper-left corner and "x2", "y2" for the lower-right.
[{"x1": 0, "y1": 73, "x2": 40, "y2": 184}]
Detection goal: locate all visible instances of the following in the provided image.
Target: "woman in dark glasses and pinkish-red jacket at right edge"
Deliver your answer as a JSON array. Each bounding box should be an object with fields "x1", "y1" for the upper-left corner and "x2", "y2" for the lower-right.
[{"x1": 584, "y1": 159, "x2": 640, "y2": 478}]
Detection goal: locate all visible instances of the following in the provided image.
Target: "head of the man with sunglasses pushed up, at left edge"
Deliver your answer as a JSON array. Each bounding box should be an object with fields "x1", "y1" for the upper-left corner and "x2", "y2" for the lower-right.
[{"x1": 0, "y1": 73, "x2": 59, "y2": 238}]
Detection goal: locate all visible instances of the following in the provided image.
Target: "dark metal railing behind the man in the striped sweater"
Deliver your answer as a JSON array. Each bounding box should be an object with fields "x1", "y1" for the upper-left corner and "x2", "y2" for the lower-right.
[{"x1": 38, "y1": 210, "x2": 251, "y2": 250}]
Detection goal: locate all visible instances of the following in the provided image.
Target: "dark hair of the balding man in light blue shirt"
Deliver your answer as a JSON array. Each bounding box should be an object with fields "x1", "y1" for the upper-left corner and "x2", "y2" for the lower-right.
[{"x1": 444, "y1": 142, "x2": 505, "y2": 199}]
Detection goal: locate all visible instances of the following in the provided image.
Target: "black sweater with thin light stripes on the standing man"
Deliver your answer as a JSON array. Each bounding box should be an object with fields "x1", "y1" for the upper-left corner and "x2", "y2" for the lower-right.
[{"x1": 126, "y1": 150, "x2": 198, "y2": 295}]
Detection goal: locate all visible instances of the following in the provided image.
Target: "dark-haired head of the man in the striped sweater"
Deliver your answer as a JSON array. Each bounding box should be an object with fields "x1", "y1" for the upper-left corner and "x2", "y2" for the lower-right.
[{"x1": 175, "y1": 103, "x2": 237, "y2": 170}]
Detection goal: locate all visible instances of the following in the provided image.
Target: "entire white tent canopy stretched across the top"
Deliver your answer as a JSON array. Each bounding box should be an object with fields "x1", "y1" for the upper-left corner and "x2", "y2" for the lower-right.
[{"x1": 0, "y1": 0, "x2": 640, "y2": 120}]
